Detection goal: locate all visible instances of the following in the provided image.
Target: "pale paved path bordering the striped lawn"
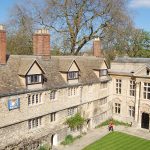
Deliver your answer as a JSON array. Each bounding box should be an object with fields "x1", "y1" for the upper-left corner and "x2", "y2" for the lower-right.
[{"x1": 56, "y1": 126, "x2": 150, "y2": 150}]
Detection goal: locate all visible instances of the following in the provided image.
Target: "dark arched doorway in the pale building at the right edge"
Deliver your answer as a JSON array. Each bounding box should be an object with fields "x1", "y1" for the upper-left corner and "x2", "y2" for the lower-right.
[{"x1": 141, "y1": 113, "x2": 149, "y2": 129}]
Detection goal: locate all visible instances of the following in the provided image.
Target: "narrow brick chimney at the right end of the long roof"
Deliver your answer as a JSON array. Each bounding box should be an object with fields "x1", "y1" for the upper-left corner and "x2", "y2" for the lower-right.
[{"x1": 93, "y1": 38, "x2": 102, "y2": 57}]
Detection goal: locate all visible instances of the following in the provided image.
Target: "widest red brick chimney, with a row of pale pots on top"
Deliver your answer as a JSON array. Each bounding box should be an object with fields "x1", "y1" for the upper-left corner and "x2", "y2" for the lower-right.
[{"x1": 33, "y1": 29, "x2": 50, "y2": 60}]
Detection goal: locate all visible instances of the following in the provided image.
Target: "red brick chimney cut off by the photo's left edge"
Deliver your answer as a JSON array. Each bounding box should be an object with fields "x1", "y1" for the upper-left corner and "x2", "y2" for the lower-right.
[{"x1": 0, "y1": 25, "x2": 6, "y2": 65}]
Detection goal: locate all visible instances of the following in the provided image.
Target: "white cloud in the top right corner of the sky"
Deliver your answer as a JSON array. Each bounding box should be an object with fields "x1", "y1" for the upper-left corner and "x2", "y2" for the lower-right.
[{"x1": 129, "y1": 0, "x2": 150, "y2": 8}]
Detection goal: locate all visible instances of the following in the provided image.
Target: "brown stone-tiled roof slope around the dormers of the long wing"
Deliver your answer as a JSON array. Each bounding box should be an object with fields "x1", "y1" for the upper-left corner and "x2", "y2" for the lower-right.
[{"x1": 0, "y1": 55, "x2": 108, "y2": 96}]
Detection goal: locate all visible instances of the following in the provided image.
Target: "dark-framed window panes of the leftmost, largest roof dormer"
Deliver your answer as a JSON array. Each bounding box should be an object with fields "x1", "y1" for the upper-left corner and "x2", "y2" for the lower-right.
[{"x1": 26, "y1": 74, "x2": 42, "y2": 85}]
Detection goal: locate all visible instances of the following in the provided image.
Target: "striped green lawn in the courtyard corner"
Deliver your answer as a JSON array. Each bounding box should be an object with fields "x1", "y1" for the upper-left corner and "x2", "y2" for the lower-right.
[{"x1": 83, "y1": 132, "x2": 150, "y2": 150}]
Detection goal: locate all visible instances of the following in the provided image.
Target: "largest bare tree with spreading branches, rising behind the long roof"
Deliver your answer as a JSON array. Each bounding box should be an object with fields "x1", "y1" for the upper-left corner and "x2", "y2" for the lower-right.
[{"x1": 7, "y1": 0, "x2": 128, "y2": 55}]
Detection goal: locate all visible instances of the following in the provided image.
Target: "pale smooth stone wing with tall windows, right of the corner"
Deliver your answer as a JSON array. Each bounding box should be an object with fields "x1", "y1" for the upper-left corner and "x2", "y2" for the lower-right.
[{"x1": 109, "y1": 56, "x2": 150, "y2": 129}]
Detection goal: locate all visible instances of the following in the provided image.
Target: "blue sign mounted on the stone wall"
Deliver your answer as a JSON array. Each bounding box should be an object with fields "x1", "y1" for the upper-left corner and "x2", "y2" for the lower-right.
[{"x1": 8, "y1": 98, "x2": 20, "y2": 110}]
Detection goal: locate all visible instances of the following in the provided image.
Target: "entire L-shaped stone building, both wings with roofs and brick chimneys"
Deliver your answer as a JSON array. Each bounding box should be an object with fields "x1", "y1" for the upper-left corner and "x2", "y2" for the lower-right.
[{"x1": 0, "y1": 25, "x2": 150, "y2": 150}]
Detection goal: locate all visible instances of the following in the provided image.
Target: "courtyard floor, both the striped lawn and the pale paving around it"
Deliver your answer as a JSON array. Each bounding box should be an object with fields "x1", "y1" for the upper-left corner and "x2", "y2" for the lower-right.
[{"x1": 56, "y1": 126, "x2": 150, "y2": 150}]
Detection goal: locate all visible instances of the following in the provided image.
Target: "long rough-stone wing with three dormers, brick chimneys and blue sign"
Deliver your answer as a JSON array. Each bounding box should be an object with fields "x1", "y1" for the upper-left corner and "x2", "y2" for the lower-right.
[{"x1": 0, "y1": 26, "x2": 112, "y2": 150}]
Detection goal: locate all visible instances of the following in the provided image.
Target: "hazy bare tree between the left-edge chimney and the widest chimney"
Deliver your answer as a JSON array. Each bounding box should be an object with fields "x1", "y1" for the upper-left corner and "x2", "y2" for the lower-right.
[{"x1": 7, "y1": 4, "x2": 34, "y2": 55}]
